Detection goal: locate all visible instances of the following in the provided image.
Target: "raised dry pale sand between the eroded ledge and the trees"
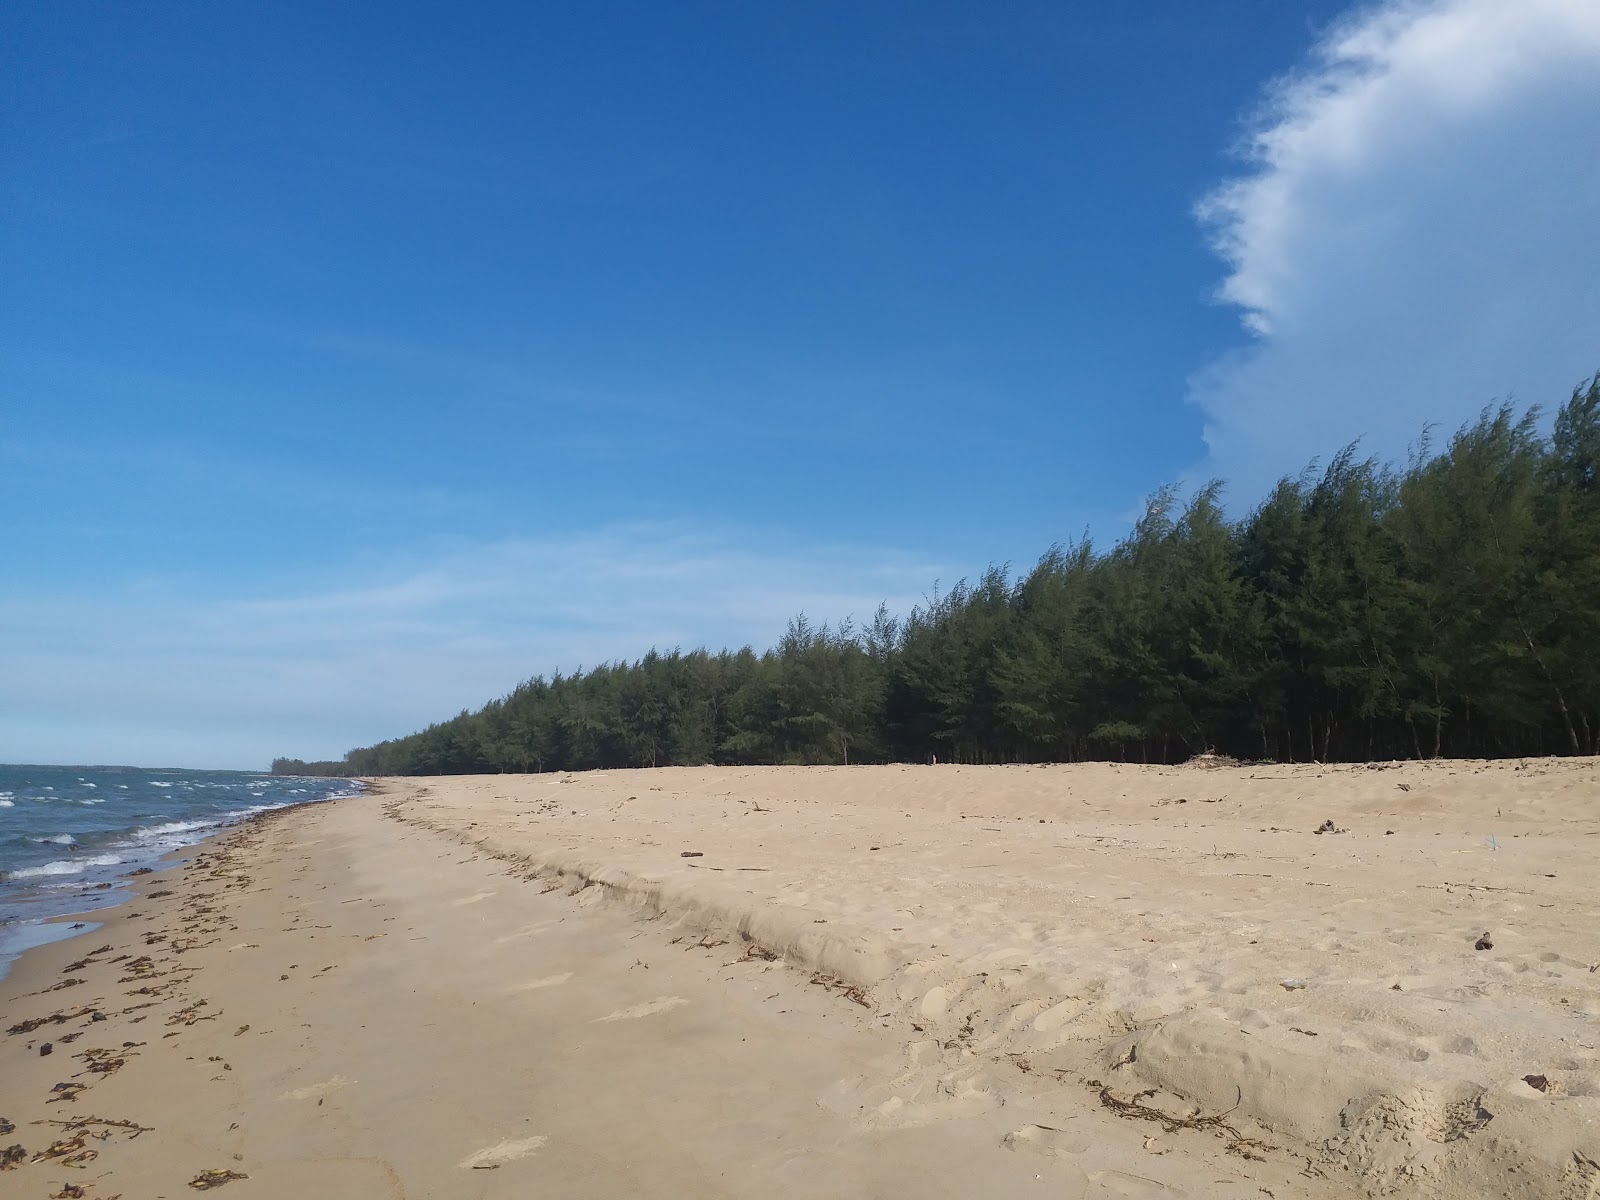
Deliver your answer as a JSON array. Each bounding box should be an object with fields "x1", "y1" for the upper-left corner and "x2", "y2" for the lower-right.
[{"x1": 389, "y1": 760, "x2": 1600, "y2": 1198}]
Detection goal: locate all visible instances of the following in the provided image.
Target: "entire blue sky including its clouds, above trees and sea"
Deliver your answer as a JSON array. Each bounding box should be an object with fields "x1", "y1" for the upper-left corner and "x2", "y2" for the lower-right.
[{"x1": 0, "y1": 0, "x2": 1600, "y2": 765}]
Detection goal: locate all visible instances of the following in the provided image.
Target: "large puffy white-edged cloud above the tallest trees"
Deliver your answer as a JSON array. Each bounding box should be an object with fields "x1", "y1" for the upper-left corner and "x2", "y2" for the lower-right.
[{"x1": 1190, "y1": 0, "x2": 1600, "y2": 504}]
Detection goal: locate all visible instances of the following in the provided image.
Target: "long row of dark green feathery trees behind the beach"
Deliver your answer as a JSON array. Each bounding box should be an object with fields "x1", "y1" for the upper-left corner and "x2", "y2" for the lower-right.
[{"x1": 274, "y1": 374, "x2": 1600, "y2": 776}]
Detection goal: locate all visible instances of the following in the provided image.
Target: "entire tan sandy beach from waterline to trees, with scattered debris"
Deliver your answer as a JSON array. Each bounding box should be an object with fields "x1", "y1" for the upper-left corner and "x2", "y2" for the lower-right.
[{"x1": 0, "y1": 760, "x2": 1600, "y2": 1200}]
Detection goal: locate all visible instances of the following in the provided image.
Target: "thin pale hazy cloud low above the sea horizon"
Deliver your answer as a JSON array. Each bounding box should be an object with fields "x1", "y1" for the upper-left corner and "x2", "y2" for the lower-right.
[{"x1": 0, "y1": 525, "x2": 949, "y2": 766}]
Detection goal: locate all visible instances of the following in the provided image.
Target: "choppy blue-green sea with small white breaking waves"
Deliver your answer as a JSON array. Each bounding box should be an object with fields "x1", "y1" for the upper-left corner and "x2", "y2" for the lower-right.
[{"x1": 0, "y1": 765, "x2": 363, "y2": 978}]
